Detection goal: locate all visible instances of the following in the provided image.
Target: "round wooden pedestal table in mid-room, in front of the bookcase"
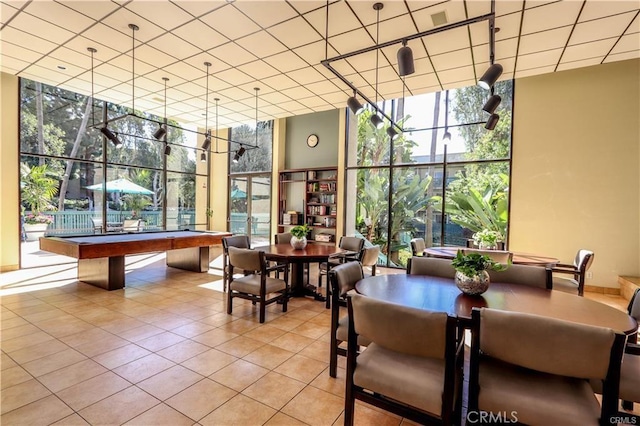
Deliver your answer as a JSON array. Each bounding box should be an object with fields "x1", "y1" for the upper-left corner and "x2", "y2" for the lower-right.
[{"x1": 260, "y1": 242, "x2": 347, "y2": 302}]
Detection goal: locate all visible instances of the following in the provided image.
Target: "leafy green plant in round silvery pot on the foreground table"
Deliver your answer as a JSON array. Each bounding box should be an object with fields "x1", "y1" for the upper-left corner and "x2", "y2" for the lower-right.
[{"x1": 451, "y1": 250, "x2": 507, "y2": 296}]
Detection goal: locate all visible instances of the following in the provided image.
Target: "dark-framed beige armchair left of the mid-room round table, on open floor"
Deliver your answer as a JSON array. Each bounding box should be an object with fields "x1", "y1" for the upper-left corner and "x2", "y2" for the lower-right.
[{"x1": 227, "y1": 247, "x2": 289, "y2": 323}]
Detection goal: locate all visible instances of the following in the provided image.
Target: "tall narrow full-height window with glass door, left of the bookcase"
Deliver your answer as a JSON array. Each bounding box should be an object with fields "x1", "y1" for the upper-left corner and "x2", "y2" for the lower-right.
[{"x1": 228, "y1": 121, "x2": 273, "y2": 246}]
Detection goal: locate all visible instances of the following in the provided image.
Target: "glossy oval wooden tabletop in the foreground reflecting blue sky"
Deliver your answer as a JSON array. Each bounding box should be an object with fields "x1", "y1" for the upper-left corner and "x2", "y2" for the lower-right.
[{"x1": 356, "y1": 274, "x2": 638, "y2": 335}]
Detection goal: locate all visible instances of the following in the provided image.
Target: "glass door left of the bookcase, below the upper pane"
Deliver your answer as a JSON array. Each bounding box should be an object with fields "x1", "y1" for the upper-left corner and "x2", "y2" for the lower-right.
[{"x1": 228, "y1": 174, "x2": 271, "y2": 247}]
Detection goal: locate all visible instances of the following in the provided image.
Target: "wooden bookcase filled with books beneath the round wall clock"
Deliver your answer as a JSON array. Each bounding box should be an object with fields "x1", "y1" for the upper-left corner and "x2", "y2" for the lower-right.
[{"x1": 278, "y1": 167, "x2": 338, "y2": 243}]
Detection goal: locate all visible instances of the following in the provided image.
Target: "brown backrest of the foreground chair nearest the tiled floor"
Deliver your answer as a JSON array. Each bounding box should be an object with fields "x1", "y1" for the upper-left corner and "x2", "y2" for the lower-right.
[{"x1": 350, "y1": 294, "x2": 448, "y2": 359}]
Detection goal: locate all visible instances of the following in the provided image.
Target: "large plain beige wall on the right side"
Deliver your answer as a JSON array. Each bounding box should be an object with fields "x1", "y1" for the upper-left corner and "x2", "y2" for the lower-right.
[{"x1": 509, "y1": 60, "x2": 640, "y2": 287}]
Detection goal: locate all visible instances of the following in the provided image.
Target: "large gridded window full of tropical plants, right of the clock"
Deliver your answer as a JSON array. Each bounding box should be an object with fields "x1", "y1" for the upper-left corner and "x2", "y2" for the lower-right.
[{"x1": 345, "y1": 81, "x2": 513, "y2": 267}]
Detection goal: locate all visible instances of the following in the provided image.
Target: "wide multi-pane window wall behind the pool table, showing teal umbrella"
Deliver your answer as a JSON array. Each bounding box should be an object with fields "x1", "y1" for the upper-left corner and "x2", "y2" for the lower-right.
[{"x1": 20, "y1": 79, "x2": 202, "y2": 267}]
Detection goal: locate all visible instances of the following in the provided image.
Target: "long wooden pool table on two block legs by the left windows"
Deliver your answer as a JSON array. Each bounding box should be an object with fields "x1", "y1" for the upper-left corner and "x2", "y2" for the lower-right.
[{"x1": 40, "y1": 231, "x2": 231, "y2": 290}]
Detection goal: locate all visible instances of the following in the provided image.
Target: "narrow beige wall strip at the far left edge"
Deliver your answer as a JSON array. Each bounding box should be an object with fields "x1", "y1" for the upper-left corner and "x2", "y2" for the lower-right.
[{"x1": 0, "y1": 73, "x2": 20, "y2": 271}]
